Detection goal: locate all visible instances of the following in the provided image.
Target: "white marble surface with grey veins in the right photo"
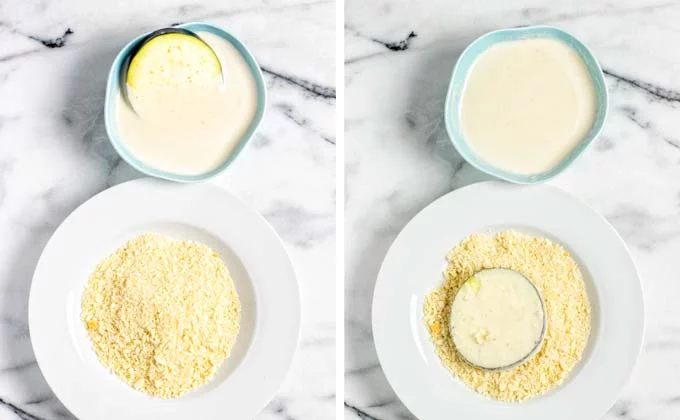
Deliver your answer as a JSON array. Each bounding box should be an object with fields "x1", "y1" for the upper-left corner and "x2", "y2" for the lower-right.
[{"x1": 345, "y1": 0, "x2": 680, "y2": 420}]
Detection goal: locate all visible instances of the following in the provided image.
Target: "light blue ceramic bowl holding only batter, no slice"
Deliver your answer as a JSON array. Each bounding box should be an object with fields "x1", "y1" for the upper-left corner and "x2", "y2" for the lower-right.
[{"x1": 444, "y1": 26, "x2": 609, "y2": 184}]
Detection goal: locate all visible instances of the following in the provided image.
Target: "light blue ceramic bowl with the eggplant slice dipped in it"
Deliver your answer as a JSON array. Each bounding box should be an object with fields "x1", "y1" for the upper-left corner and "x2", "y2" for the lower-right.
[{"x1": 104, "y1": 23, "x2": 267, "y2": 182}]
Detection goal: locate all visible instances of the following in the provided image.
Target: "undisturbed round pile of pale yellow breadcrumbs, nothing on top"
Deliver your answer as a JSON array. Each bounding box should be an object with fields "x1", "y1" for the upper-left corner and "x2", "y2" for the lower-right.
[{"x1": 81, "y1": 233, "x2": 241, "y2": 398}]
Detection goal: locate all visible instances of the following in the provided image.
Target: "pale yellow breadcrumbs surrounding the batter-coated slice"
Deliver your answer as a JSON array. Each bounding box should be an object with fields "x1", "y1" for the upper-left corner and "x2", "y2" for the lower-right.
[{"x1": 424, "y1": 231, "x2": 590, "y2": 402}]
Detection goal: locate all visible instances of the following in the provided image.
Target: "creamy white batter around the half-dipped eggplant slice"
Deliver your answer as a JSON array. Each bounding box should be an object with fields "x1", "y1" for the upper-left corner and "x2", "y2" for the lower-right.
[{"x1": 118, "y1": 32, "x2": 257, "y2": 175}]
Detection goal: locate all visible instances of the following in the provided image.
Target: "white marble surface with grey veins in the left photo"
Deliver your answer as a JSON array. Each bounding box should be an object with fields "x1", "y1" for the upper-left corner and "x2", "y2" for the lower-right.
[{"x1": 0, "y1": 0, "x2": 335, "y2": 420}]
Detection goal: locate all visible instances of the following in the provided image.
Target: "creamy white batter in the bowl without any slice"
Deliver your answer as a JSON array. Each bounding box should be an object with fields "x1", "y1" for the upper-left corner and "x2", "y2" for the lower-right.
[{"x1": 460, "y1": 39, "x2": 597, "y2": 175}]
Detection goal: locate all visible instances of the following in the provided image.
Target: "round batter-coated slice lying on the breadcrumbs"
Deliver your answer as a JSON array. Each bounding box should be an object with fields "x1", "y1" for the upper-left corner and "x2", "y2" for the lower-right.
[{"x1": 449, "y1": 269, "x2": 545, "y2": 369}]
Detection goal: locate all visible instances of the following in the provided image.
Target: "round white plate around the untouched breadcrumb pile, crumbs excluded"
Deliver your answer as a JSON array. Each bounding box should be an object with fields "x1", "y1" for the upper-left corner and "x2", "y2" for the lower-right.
[{"x1": 29, "y1": 179, "x2": 300, "y2": 420}]
